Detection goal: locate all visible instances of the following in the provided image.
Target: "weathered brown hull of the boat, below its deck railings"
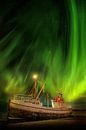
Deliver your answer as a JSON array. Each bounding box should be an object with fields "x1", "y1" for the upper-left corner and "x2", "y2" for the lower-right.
[{"x1": 8, "y1": 102, "x2": 72, "y2": 120}]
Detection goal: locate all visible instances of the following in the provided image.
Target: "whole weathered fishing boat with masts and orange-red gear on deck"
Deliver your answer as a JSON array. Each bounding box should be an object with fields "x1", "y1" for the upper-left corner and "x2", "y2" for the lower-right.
[{"x1": 8, "y1": 75, "x2": 72, "y2": 120}]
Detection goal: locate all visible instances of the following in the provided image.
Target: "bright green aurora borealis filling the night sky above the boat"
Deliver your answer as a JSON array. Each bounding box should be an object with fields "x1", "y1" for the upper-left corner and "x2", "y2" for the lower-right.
[{"x1": 0, "y1": 0, "x2": 86, "y2": 101}]
